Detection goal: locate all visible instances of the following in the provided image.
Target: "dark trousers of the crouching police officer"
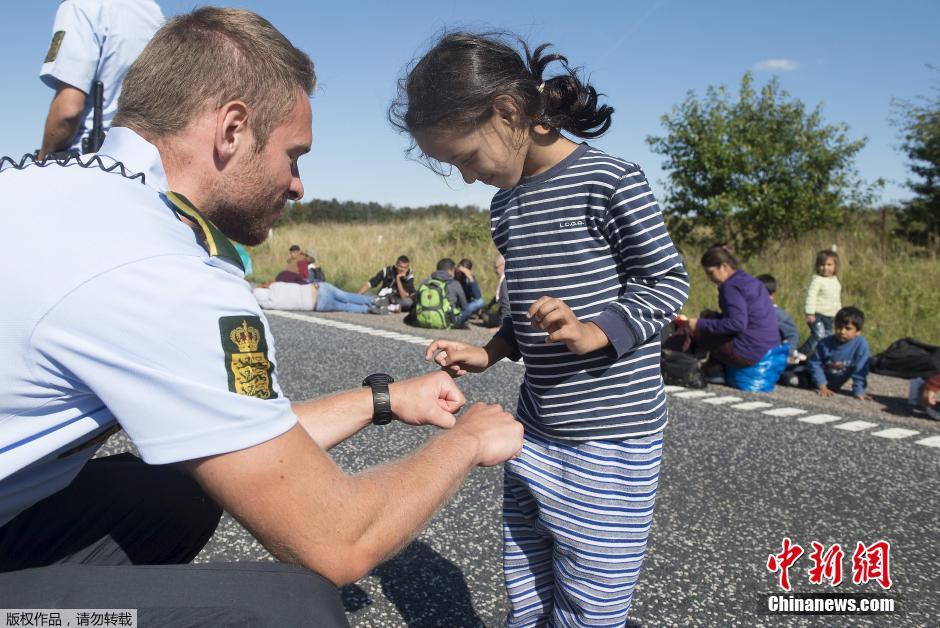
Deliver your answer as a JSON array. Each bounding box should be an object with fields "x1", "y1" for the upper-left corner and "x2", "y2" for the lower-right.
[{"x1": 0, "y1": 454, "x2": 348, "y2": 626}]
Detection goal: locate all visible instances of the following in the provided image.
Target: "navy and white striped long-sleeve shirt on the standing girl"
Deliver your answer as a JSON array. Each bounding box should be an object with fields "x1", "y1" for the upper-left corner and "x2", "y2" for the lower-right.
[{"x1": 490, "y1": 144, "x2": 689, "y2": 440}]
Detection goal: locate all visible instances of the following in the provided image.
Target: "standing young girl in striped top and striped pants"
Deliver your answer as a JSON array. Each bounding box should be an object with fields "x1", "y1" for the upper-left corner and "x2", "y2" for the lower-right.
[{"x1": 390, "y1": 33, "x2": 689, "y2": 626}]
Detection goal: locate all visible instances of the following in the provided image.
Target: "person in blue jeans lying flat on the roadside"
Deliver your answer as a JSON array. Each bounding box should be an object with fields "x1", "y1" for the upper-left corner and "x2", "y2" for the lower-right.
[{"x1": 253, "y1": 281, "x2": 385, "y2": 314}]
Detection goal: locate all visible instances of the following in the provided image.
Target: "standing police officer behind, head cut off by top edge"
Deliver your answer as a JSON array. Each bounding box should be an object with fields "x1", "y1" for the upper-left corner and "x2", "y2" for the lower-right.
[{"x1": 39, "y1": 0, "x2": 164, "y2": 158}]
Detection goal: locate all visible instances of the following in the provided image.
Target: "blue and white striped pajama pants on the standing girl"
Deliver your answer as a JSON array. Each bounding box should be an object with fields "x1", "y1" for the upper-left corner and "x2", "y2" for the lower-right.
[{"x1": 503, "y1": 432, "x2": 663, "y2": 628}]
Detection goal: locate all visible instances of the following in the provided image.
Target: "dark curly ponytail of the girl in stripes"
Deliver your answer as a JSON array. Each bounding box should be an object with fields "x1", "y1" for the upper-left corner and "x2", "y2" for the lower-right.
[{"x1": 522, "y1": 42, "x2": 614, "y2": 139}]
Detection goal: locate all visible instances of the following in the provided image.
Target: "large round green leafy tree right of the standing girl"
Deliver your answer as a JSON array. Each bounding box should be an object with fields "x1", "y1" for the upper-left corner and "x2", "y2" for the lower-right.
[{"x1": 646, "y1": 73, "x2": 872, "y2": 257}]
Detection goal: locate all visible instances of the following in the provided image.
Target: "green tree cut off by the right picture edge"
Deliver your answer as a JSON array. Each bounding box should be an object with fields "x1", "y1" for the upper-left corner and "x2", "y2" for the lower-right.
[{"x1": 894, "y1": 74, "x2": 940, "y2": 256}]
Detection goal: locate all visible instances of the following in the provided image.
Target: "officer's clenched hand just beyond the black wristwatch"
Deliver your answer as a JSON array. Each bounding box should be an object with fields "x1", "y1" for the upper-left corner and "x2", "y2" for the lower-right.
[{"x1": 388, "y1": 372, "x2": 467, "y2": 428}]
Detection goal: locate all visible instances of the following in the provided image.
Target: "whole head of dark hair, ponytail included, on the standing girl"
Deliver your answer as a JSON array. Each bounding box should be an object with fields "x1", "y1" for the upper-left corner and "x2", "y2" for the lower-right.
[{"x1": 388, "y1": 33, "x2": 614, "y2": 138}]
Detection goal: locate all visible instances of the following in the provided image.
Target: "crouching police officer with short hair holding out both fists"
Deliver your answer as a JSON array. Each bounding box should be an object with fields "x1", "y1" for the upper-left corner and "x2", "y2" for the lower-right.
[{"x1": 0, "y1": 8, "x2": 522, "y2": 626}]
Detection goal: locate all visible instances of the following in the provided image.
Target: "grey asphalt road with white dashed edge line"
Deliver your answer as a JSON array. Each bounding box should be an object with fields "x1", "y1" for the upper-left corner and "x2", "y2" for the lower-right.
[{"x1": 104, "y1": 313, "x2": 940, "y2": 627}]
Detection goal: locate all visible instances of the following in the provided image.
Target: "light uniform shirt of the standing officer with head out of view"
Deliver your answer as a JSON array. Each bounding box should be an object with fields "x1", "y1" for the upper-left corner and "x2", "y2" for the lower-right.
[{"x1": 39, "y1": 0, "x2": 164, "y2": 150}]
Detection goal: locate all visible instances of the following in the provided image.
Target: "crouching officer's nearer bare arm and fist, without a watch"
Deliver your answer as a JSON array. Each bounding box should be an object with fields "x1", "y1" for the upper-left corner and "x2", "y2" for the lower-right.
[{"x1": 187, "y1": 404, "x2": 522, "y2": 585}]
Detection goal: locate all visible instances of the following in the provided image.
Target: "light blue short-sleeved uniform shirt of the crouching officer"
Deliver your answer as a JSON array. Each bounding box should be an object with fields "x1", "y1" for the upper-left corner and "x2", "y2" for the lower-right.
[{"x1": 0, "y1": 128, "x2": 297, "y2": 525}]
